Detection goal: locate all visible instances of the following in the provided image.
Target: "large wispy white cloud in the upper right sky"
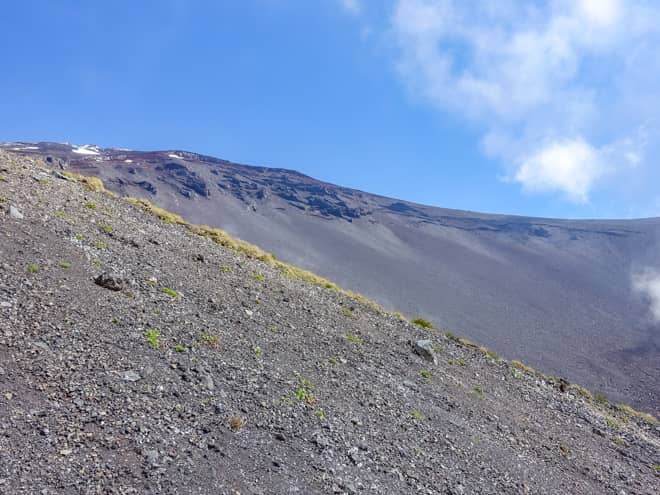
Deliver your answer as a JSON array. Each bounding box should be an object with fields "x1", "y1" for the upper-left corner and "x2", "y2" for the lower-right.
[{"x1": 391, "y1": 0, "x2": 660, "y2": 203}]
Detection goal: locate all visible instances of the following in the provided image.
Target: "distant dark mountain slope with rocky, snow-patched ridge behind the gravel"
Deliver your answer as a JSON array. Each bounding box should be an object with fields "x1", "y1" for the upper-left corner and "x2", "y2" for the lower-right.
[{"x1": 3, "y1": 143, "x2": 660, "y2": 414}]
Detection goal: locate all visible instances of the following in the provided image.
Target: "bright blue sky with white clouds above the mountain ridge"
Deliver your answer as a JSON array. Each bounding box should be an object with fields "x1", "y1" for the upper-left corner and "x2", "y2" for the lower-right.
[{"x1": 0, "y1": 0, "x2": 660, "y2": 218}]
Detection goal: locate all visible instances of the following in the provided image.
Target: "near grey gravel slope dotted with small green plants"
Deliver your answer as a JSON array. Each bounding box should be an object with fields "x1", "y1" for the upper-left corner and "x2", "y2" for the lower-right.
[{"x1": 0, "y1": 151, "x2": 660, "y2": 495}]
